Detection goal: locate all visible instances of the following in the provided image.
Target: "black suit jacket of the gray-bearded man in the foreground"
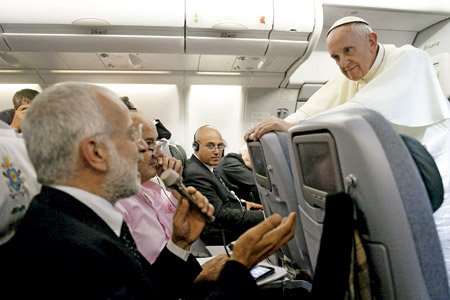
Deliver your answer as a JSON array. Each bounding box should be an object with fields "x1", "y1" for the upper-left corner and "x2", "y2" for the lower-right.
[{"x1": 0, "y1": 186, "x2": 201, "y2": 299}]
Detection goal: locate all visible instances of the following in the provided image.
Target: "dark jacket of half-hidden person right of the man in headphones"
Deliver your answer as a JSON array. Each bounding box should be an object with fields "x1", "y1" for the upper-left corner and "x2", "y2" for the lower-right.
[{"x1": 216, "y1": 153, "x2": 261, "y2": 204}]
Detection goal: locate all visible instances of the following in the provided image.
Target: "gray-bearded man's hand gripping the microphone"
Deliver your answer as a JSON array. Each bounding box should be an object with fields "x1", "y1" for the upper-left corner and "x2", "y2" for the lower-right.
[{"x1": 172, "y1": 187, "x2": 214, "y2": 251}]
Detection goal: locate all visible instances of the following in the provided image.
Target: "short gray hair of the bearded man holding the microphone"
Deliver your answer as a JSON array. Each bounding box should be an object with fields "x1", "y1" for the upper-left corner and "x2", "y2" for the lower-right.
[{"x1": 21, "y1": 82, "x2": 122, "y2": 185}]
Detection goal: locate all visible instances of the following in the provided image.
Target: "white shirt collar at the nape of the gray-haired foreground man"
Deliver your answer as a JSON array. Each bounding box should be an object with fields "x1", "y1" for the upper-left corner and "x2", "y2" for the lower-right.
[{"x1": 51, "y1": 185, "x2": 123, "y2": 237}]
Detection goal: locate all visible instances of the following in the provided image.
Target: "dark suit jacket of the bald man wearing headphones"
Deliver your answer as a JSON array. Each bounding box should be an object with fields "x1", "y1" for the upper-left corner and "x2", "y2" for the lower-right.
[{"x1": 183, "y1": 155, "x2": 264, "y2": 245}]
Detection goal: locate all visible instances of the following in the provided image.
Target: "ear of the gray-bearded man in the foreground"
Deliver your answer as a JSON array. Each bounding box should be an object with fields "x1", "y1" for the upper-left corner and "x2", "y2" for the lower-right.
[{"x1": 80, "y1": 137, "x2": 109, "y2": 172}]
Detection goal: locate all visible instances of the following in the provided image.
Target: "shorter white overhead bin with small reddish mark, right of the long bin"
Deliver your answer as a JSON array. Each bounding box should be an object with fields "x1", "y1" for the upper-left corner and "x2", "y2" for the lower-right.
[{"x1": 186, "y1": 0, "x2": 273, "y2": 55}]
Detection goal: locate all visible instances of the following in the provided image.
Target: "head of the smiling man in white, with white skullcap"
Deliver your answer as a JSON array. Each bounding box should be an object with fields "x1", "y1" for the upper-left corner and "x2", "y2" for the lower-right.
[{"x1": 327, "y1": 22, "x2": 378, "y2": 81}]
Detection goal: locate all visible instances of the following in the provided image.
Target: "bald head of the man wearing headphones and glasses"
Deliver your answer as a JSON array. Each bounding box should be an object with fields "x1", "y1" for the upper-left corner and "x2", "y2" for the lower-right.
[{"x1": 194, "y1": 126, "x2": 224, "y2": 166}]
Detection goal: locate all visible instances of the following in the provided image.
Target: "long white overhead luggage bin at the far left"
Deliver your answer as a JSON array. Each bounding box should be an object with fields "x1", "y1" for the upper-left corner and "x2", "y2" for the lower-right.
[{"x1": 0, "y1": 0, "x2": 185, "y2": 53}]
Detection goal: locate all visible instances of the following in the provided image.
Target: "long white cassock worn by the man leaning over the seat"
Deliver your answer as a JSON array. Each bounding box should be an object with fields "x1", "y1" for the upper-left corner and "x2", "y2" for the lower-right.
[{"x1": 285, "y1": 45, "x2": 450, "y2": 282}]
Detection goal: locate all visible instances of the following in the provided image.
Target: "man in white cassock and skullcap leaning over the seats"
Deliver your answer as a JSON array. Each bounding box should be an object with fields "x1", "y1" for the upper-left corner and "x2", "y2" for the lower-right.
[{"x1": 245, "y1": 17, "x2": 450, "y2": 286}]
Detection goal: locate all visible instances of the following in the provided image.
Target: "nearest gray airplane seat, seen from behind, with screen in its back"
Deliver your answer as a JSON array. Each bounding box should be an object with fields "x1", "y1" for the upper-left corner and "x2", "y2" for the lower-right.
[{"x1": 288, "y1": 108, "x2": 450, "y2": 300}]
